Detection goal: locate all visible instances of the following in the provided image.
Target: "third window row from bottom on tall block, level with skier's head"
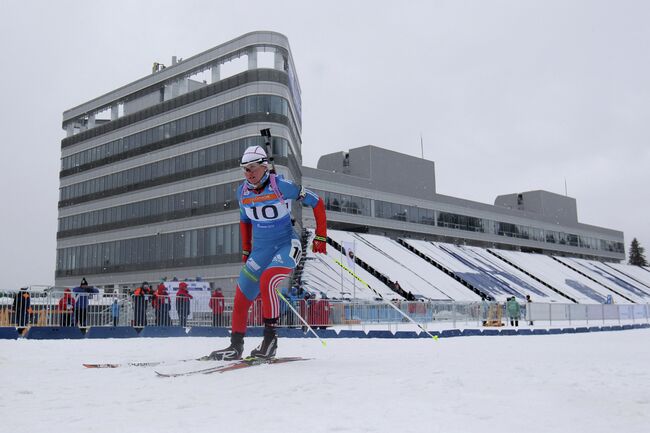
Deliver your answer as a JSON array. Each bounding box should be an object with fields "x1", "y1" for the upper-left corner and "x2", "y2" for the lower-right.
[{"x1": 60, "y1": 136, "x2": 290, "y2": 204}]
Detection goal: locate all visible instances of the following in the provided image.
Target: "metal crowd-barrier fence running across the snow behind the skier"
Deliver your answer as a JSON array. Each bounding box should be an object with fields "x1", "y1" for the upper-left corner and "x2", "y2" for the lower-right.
[{"x1": 0, "y1": 290, "x2": 650, "y2": 328}]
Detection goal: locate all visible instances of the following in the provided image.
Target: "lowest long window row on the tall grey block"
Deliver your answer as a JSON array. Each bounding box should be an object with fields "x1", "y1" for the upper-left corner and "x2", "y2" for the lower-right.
[{"x1": 56, "y1": 224, "x2": 241, "y2": 276}]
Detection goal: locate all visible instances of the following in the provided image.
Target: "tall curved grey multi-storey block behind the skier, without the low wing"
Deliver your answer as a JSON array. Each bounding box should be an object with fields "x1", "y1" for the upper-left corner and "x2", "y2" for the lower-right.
[{"x1": 56, "y1": 32, "x2": 302, "y2": 287}]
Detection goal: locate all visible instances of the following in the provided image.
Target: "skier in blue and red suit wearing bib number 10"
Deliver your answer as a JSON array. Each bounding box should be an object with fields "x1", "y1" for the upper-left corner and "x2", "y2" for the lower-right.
[{"x1": 208, "y1": 146, "x2": 327, "y2": 360}]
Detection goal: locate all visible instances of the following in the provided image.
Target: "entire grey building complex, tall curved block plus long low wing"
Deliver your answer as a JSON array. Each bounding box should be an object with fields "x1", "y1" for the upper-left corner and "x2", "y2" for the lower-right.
[{"x1": 56, "y1": 32, "x2": 624, "y2": 291}]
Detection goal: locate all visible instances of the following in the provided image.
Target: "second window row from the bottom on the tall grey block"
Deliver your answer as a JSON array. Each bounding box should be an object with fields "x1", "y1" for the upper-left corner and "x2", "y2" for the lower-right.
[{"x1": 58, "y1": 181, "x2": 241, "y2": 238}]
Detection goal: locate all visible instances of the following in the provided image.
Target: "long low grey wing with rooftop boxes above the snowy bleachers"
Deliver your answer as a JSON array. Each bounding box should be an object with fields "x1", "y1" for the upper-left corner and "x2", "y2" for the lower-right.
[{"x1": 302, "y1": 146, "x2": 625, "y2": 261}]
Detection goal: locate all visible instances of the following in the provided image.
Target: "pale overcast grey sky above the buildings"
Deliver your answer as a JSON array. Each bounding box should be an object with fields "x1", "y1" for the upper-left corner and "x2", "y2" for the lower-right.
[{"x1": 0, "y1": 0, "x2": 650, "y2": 289}]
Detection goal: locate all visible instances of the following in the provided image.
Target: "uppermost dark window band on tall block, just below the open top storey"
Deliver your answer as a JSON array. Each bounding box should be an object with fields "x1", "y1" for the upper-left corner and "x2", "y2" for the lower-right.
[{"x1": 61, "y1": 95, "x2": 289, "y2": 170}]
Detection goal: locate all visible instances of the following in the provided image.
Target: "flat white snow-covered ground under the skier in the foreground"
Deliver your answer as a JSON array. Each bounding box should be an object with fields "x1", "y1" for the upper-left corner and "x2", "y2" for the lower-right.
[{"x1": 0, "y1": 329, "x2": 650, "y2": 433}]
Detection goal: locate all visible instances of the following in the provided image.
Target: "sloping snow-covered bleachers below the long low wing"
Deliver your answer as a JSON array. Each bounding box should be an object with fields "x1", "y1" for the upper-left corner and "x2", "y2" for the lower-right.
[{"x1": 296, "y1": 230, "x2": 650, "y2": 304}]
